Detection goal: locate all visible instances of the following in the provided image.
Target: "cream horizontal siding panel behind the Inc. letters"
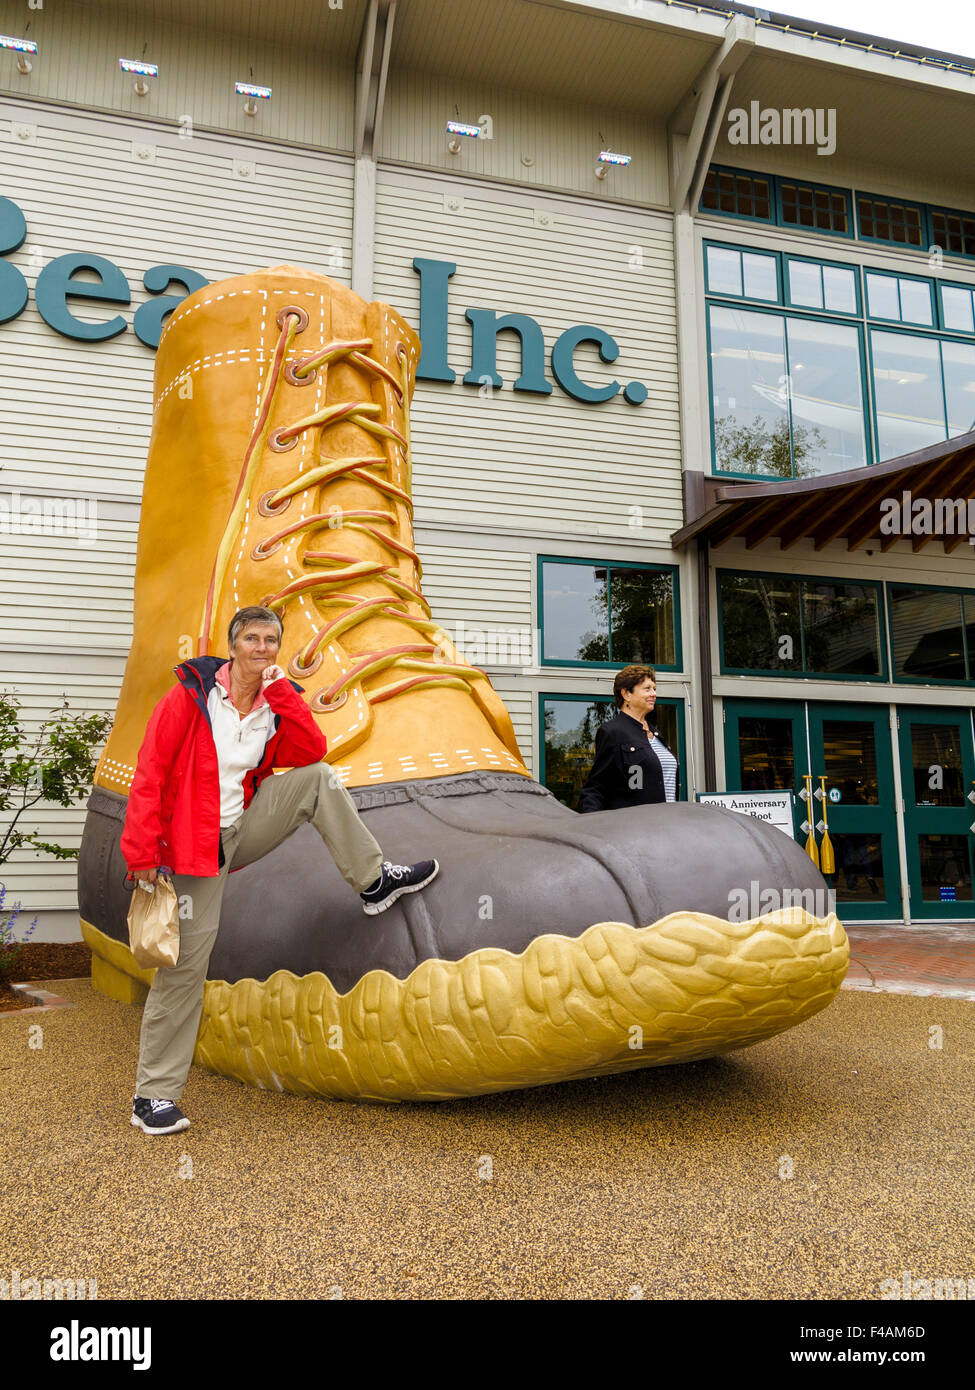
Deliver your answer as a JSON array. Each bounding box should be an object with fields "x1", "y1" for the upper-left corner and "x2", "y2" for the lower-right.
[{"x1": 374, "y1": 167, "x2": 683, "y2": 543}]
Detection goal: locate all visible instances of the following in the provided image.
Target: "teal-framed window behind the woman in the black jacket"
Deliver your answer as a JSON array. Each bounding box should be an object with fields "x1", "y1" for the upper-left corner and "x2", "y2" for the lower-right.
[{"x1": 538, "y1": 695, "x2": 687, "y2": 810}]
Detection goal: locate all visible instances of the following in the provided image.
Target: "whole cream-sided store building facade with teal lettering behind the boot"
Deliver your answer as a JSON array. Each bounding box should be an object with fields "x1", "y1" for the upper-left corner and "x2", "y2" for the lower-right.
[{"x1": 0, "y1": 0, "x2": 975, "y2": 940}]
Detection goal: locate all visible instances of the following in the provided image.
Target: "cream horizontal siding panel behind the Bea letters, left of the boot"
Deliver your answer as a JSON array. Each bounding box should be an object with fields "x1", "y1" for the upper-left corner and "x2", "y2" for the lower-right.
[{"x1": 0, "y1": 99, "x2": 352, "y2": 500}]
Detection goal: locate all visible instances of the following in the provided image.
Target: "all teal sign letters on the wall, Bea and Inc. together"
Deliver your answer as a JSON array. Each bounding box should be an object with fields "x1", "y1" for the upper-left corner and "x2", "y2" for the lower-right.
[{"x1": 0, "y1": 197, "x2": 647, "y2": 406}]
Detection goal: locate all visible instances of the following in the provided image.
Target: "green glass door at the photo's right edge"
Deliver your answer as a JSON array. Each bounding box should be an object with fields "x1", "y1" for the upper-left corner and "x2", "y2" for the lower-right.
[{"x1": 897, "y1": 706, "x2": 975, "y2": 919}]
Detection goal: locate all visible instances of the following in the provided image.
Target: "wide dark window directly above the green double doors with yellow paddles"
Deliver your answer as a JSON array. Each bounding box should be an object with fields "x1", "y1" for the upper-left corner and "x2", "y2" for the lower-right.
[{"x1": 718, "y1": 570, "x2": 885, "y2": 680}]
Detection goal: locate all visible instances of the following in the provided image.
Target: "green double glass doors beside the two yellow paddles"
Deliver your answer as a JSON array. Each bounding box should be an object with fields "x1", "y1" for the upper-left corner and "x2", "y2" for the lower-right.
[{"x1": 725, "y1": 701, "x2": 895, "y2": 920}]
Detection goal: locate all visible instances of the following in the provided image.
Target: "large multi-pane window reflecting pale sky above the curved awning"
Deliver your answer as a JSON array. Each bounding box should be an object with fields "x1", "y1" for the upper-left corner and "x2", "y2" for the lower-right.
[{"x1": 705, "y1": 242, "x2": 975, "y2": 478}]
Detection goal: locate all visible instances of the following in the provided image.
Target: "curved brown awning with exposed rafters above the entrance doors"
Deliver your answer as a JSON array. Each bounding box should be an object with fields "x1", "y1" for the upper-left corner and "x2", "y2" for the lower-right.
[{"x1": 670, "y1": 431, "x2": 975, "y2": 555}]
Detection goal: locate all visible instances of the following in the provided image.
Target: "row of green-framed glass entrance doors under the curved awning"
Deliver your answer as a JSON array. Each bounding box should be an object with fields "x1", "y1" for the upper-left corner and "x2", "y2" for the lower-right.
[{"x1": 725, "y1": 699, "x2": 975, "y2": 920}]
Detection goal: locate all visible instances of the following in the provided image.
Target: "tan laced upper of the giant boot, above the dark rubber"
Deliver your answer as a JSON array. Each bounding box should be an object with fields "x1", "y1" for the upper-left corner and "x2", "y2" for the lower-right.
[{"x1": 95, "y1": 265, "x2": 527, "y2": 794}]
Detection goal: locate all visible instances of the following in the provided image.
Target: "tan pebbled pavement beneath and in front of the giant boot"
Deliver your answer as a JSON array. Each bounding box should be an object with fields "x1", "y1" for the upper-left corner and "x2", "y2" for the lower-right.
[{"x1": 0, "y1": 980, "x2": 975, "y2": 1300}]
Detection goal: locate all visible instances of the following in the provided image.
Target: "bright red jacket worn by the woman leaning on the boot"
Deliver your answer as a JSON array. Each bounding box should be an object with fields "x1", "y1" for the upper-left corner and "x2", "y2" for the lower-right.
[{"x1": 121, "y1": 656, "x2": 325, "y2": 878}]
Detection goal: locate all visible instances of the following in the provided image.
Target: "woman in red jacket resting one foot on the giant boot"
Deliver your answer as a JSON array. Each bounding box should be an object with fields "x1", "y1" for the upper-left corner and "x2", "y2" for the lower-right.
[{"x1": 121, "y1": 607, "x2": 438, "y2": 1134}]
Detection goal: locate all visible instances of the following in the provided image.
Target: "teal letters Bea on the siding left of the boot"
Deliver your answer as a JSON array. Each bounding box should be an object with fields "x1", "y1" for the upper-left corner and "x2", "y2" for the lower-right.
[{"x1": 0, "y1": 197, "x2": 210, "y2": 348}]
